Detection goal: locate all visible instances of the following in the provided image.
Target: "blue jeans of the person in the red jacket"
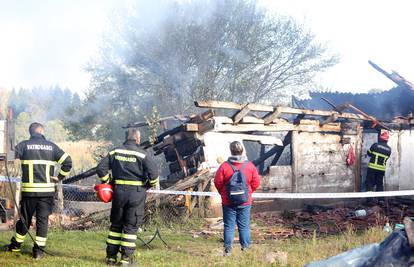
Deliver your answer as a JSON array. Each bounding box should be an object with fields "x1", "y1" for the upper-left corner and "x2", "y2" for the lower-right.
[{"x1": 223, "y1": 205, "x2": 251, "y2": 250}]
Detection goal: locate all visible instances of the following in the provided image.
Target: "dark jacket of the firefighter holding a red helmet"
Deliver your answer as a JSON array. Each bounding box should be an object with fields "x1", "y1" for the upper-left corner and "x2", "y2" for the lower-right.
[{"x1": 97, "y1": 140, "x2": 159, "y2": 186}]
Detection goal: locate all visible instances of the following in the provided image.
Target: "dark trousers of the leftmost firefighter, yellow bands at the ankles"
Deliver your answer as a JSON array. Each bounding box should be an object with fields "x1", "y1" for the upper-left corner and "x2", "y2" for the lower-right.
[{"x1": 11, "y1": 197, "x2": 54, "y2": 249}]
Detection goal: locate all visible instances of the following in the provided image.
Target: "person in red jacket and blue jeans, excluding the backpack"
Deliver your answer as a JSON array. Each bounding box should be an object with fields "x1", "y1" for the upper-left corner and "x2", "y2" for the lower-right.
[{"x1": 214, "y1": 141, "x2": 260, "y2": 256}]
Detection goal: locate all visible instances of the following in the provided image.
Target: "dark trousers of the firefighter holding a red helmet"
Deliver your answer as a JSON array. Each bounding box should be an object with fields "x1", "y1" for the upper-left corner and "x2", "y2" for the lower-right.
[{"x1": 106, "y1": 185, "x2": 147, "y2": 258}]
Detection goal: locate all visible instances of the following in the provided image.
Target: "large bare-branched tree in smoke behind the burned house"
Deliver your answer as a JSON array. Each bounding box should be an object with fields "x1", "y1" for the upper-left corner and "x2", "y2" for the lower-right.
[{"x1": 75, "y1": 0, "x2": 337, "y2": 141}]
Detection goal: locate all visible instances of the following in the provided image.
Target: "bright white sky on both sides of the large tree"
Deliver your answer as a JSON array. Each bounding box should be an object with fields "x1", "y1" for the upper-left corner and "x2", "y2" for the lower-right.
[{"x1": 0, "y1": 0, "x2": 414, "y2": 93}]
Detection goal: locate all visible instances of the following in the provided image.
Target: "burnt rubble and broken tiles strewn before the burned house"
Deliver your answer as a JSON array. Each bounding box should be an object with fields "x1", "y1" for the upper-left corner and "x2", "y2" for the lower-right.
[{"x1": 253, "y1": 198, "x2": 414, "y2": 240}]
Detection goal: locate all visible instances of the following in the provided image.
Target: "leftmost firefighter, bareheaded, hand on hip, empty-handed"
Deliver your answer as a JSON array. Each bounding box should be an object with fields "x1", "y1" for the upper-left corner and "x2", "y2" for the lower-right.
[{"x1": 8, "y1": 122, "x2": 72, "y2": 259}]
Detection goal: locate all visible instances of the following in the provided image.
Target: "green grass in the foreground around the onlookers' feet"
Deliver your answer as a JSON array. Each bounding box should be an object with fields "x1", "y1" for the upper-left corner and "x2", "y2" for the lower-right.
[{"x1": 0, "y1": 228, "x2": 386, "y2": 267}]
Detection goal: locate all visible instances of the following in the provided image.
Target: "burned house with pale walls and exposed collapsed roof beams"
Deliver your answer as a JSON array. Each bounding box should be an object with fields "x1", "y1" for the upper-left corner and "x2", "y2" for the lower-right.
[{"x1": 135, "y1": 101, "x2": 414, "y2": 199}]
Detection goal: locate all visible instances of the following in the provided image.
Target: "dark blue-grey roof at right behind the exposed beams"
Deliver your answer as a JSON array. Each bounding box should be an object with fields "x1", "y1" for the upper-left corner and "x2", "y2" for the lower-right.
[{"x1": 297, "y1": 86, "x2": 414, "y2": 120}]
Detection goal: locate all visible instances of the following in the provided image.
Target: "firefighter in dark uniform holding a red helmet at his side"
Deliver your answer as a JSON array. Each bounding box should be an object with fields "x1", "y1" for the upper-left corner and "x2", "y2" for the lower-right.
[{"x1": 97, "y1": 128, "x2": 159, "y2": 266}]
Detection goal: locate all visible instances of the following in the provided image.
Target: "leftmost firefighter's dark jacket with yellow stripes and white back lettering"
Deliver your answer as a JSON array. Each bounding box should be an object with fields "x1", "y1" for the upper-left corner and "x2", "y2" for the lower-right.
[{"x1": 15, "y1": 134, "x2": 72, "y2": 197}]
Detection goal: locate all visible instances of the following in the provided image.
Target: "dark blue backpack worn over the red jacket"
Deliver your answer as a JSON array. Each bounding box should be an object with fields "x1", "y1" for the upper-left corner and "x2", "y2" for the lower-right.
[{"x1": 226, "y1": 161, "x2": 249, "y2": 206}]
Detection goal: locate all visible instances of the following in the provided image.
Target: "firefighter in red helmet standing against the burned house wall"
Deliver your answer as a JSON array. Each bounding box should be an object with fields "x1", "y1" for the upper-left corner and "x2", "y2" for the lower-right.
[{"x1": 365, "y1": 131, "x2": 391, "y2": 191}]
